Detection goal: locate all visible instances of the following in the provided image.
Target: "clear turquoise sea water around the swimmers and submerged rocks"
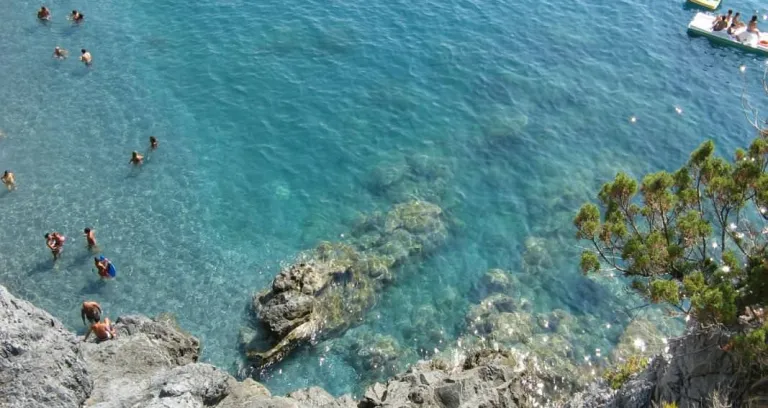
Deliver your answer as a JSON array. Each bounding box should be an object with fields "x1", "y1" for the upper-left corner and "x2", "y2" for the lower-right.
[{"x1": 0, "y1": 0, "x2": 763, "y2": 393}]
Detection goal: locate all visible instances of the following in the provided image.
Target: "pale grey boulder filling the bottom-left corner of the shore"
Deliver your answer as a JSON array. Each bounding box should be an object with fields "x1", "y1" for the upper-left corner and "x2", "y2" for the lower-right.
[{"x1": 0, "y1": 286, "x2": 93, "y2": 408}]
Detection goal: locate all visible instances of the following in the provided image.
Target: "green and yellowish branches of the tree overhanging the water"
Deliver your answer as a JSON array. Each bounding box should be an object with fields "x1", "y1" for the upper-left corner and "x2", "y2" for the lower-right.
[{"x1": 574, "y1": 132, "x2": 768, "y2": 324}]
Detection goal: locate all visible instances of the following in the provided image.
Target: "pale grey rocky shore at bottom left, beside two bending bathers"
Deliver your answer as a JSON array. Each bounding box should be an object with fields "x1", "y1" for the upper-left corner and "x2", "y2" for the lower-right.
[{"x1": 0, "y1": 286, "x2": 348, "y2": 408}]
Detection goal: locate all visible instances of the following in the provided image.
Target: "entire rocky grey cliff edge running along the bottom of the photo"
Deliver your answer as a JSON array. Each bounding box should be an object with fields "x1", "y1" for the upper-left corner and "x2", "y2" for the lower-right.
[{"x1": 0, "y1": 286, "x2": 762, "y2": 408}]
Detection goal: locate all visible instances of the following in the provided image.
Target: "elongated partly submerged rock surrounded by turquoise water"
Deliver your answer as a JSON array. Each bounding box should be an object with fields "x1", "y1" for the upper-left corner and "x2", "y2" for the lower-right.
[{"x1": 245, "y1": 201, "x2": 447, "y2": 368}]
